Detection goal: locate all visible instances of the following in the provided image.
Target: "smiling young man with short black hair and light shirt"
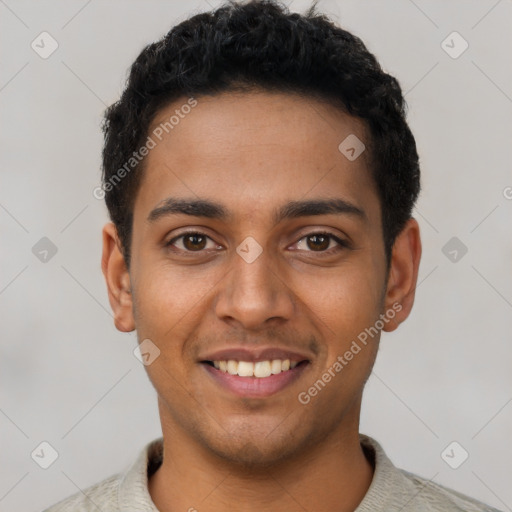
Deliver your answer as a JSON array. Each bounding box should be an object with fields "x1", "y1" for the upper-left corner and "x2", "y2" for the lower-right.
[{"x1": 43, "y1": 1, "x2": 500, "y2": 512}]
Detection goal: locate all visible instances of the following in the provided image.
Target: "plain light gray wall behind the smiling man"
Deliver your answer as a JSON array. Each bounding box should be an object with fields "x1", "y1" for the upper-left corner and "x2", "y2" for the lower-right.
[{"x1": 0, "y1": 0, "x2": 512, "y2": 512}]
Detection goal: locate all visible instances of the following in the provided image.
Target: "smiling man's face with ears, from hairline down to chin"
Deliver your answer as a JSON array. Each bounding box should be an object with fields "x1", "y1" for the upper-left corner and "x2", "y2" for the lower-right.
[{"x1": 103, "y1": 92, "x2": 417, "y2": 464}]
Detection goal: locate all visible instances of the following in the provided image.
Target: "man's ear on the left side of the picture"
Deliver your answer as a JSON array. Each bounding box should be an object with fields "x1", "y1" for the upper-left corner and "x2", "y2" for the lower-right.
[{"x1": 101, "y1": 222, "x2": 135, "y2": 332}]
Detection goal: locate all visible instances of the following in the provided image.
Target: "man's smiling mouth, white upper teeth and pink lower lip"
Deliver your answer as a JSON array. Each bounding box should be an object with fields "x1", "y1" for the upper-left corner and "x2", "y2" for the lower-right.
[{"x1": 201, "y1": 359, "x2": 311, "y2": 398}]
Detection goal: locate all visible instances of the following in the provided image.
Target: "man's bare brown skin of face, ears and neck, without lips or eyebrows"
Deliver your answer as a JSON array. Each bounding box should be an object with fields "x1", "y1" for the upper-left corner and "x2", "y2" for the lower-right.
[{"x1": 102, "y1": 92, "x2": 421, "y2": 512}]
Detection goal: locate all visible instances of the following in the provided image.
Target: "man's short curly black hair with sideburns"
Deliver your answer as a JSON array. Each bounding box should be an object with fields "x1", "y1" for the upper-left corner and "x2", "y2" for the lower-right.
[{"x1": 102, "y1": 0, "x2": 420, "y2": 270}]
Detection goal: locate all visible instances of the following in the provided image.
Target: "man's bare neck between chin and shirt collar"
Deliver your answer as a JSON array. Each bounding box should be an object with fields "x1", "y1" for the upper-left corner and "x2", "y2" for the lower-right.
[{"x1": 148, "y1": 402, "x2": 373, "y2": 512}]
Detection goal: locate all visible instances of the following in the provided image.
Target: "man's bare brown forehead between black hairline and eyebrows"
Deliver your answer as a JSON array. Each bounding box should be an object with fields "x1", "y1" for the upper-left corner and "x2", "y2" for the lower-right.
[{"x1": 135, "y1": 92, "x2": 379, "y2": 226}]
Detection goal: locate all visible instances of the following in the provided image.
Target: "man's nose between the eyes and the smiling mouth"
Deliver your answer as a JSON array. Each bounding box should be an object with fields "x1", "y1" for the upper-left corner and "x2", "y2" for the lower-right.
[{"x1": 215, "y1": 242, "x2": 296, "y2": 330}]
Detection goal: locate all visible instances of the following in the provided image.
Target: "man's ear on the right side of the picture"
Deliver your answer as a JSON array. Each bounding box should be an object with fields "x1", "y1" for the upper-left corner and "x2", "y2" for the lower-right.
[{"x1": 382, "y1": 218, "x2": 421, "y2": 332}]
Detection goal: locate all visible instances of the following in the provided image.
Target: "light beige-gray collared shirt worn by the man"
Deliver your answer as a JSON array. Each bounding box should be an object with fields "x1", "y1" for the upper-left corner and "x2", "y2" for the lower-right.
[{"x1": 44, "y1": 434, "x2": 499, "y2": 512}]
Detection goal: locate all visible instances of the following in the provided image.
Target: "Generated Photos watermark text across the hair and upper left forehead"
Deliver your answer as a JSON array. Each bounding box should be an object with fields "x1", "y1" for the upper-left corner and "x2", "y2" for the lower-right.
[{"x1": 92, "y1": 97, "x2": 197, "y2": 200}]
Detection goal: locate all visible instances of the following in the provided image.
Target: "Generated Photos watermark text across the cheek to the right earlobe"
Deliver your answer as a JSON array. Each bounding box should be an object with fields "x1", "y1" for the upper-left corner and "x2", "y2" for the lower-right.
[{"x1": 297, "y1": 302, "x2": 402, "y2": 405}]
